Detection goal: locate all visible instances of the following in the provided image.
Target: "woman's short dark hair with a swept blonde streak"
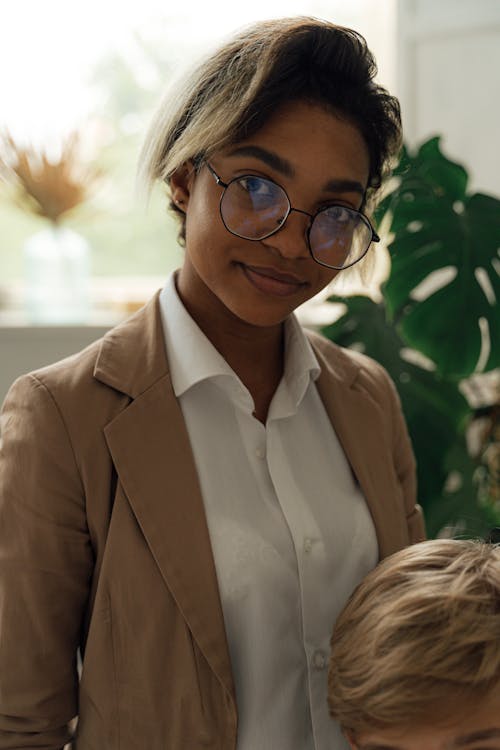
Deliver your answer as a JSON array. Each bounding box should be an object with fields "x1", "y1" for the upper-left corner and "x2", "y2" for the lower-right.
[{"x1": 139, "y1": 17, "x2": 401, "y2": 239}]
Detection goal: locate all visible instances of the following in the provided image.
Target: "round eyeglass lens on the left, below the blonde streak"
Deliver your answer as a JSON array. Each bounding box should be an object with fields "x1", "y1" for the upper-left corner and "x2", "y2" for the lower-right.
[{"x1": 220, "y1": 175, "x2": 290, "y2": 240}]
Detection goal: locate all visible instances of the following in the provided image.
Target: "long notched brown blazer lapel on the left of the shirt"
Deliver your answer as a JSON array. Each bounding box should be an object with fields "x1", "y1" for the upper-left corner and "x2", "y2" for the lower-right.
[{"x1": 94, "y1": 298, "x2": 234, "y2": 695}]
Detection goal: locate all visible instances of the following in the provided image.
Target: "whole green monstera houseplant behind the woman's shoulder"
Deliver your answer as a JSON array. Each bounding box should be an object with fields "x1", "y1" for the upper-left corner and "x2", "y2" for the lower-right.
[{"x1": 323, "y1": 137, "x2": 500, "y2": 537}]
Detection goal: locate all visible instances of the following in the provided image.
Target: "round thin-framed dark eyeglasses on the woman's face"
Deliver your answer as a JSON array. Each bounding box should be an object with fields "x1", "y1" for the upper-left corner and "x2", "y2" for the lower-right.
[{"x1": 205, "y1": 162, "x2": 380, "y2": 270}]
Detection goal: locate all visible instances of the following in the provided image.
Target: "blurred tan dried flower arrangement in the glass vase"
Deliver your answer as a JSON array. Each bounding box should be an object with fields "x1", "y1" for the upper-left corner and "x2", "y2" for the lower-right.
[{"x1": 0, "y1": 133, "x2": 100, "y2": 225}]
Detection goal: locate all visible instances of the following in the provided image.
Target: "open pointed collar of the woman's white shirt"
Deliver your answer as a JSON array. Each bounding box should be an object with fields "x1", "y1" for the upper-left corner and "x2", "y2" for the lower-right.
[{"x1": 160, "y1": 272, "x2": 321, "y2": 406}]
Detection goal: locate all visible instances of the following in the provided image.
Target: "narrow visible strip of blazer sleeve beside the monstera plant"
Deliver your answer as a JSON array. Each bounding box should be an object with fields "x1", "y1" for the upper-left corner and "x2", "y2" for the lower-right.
[{"x1": 384, "y1": 371, "x2": 426, "y2": 544}]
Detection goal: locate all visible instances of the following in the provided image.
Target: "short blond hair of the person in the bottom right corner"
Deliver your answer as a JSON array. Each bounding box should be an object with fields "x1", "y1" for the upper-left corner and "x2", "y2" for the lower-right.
[{"x1": 328, "y1": 540, "x2": 500, "y2": 737}]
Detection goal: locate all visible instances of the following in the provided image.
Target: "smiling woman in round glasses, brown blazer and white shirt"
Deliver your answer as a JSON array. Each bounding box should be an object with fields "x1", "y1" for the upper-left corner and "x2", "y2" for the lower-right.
[{"x1": 0, "y1": 18, "x2": 423, "y2": 750}]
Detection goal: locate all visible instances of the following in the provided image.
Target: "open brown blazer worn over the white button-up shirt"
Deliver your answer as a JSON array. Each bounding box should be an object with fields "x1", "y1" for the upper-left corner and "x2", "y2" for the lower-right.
[{"x1": 0, "y1": 298, "x2": 424, "y2": 750}]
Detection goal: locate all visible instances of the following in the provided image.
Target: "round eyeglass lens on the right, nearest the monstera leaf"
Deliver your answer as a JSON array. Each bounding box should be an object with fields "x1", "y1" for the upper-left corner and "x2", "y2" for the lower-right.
[{"x1": 309, "y1": 206, "x2": 372, "y2": 268}]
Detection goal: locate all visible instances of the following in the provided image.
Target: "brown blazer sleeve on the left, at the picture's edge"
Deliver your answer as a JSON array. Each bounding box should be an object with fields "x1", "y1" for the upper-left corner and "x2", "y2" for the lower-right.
[{"x1": 0, "y1": 375, "x2": 93, "y2": 750}]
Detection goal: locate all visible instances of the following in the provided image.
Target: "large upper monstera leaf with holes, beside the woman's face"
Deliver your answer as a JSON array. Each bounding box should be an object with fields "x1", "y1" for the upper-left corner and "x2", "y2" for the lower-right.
[{"x1": 377, "y1": 138, "x2": 500, "y2": 379}]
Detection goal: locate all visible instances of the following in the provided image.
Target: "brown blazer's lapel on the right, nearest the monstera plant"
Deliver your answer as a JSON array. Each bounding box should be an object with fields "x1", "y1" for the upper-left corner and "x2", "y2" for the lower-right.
[{"x1": 309, "y1": 335, "x2": 408, "y2": 558}]
